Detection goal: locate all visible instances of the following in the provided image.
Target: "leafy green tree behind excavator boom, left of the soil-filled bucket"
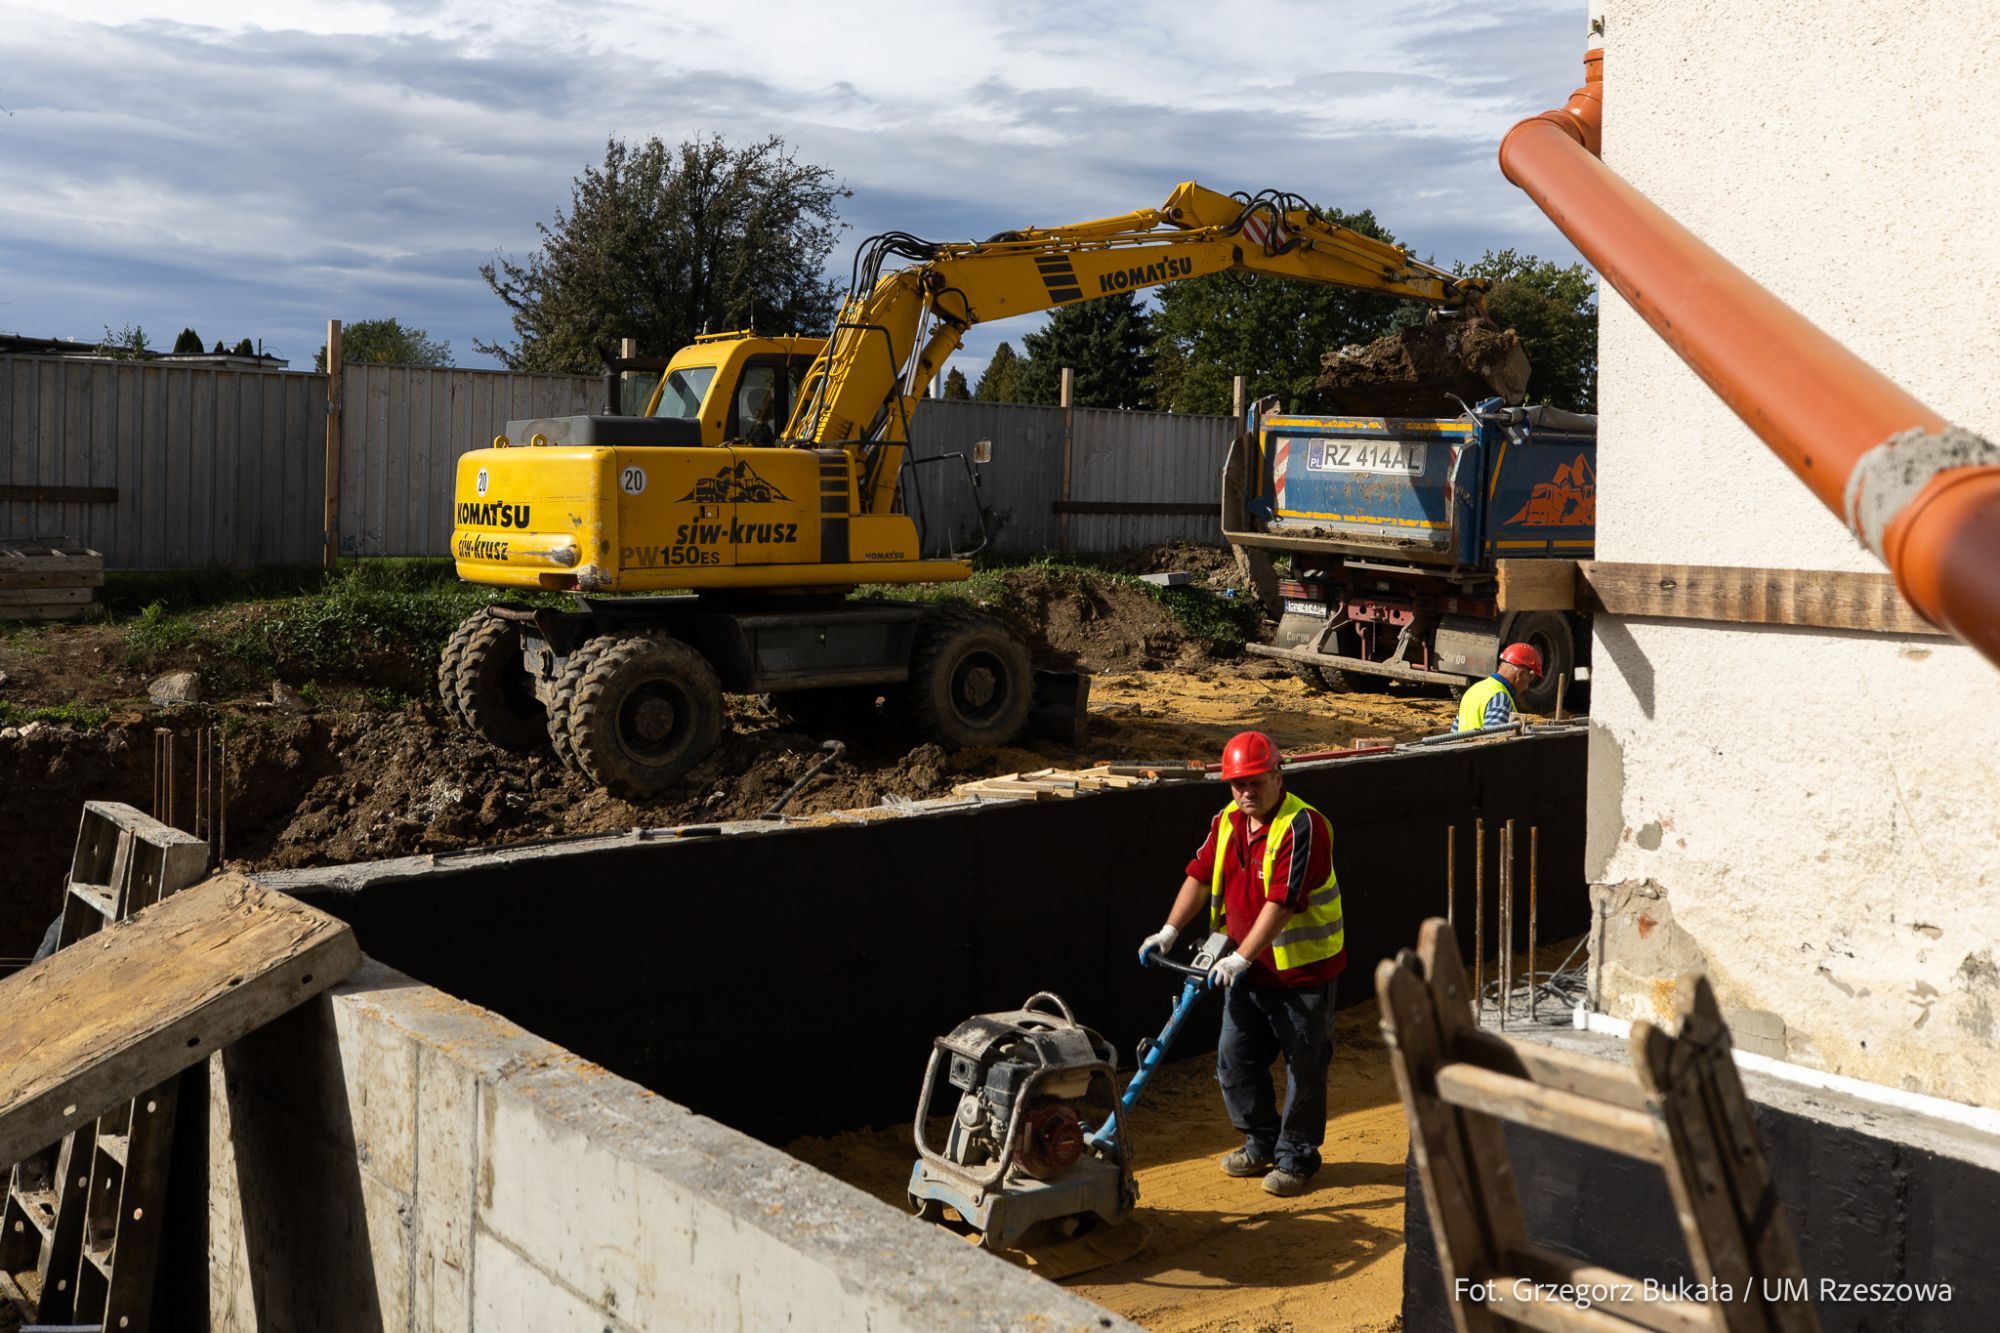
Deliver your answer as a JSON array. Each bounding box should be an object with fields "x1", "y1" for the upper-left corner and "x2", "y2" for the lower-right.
[{"x1": 1152, "y1": 208, "x2": 1400, "y2": 412}]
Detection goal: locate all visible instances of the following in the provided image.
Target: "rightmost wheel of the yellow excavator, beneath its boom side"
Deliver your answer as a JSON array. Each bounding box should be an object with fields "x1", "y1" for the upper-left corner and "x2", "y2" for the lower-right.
[{"x1": 910, "y1": 606, "x2": 1034, "y2": 749}]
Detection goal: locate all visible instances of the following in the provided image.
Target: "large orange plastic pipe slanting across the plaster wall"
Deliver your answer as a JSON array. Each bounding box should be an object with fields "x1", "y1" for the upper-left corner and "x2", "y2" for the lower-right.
[{"x1": 1500, "y1": 50, "x2": 2000, "y2": 664}]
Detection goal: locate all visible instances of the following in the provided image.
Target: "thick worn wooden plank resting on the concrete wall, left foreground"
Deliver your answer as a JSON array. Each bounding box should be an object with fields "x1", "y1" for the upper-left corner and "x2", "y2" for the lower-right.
[{"x1": 0, "y1": 877, "x2": 360, "y2": 1161}]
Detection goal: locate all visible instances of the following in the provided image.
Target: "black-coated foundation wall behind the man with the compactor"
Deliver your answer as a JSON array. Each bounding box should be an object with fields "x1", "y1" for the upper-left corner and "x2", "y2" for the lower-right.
[{"x1": 256, "y1": 729, "x2": 1586, "y2": 1143}]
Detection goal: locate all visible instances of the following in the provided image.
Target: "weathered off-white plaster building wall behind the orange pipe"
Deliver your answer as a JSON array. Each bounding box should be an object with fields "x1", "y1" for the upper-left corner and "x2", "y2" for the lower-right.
[{"x1": 1588, "y1": 0, "x2": 2000, "y2": 1105}]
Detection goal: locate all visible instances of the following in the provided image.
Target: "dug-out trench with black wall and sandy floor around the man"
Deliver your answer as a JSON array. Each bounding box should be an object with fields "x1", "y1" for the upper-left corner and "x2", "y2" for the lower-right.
[{"x1": 254, "y1": 729, "x2": 1588, "y2": 1329}]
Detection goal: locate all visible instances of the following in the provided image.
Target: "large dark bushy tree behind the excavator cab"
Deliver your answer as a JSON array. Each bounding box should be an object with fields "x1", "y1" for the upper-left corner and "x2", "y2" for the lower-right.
[{"x1": 474, "y1": 136, "x2": 850, "y2": 374}]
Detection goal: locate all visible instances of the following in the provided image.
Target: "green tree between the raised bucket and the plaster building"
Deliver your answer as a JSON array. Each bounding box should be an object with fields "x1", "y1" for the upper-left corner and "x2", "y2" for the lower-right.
[{"x1": 1466, "y1": 250, "x2": 1598, "y2": 412}]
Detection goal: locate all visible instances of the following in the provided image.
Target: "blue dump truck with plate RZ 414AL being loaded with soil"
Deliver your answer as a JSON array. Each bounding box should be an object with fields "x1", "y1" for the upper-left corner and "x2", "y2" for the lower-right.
[{"x1": 1222, "y1": 398, "x2": 1596, "y2": 713}]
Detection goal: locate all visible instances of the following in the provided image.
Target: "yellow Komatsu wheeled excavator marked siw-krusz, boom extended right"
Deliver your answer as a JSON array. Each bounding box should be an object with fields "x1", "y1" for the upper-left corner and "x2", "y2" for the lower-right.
[{"x1": 438, "y1": 182, "x2": 1486, "y2": 799}]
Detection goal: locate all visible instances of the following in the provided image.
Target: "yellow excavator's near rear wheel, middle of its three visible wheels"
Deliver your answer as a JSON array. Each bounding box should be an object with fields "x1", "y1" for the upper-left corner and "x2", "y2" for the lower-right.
[{"x1": 570, "y1": 634, "x2": 722, "y2": 801}]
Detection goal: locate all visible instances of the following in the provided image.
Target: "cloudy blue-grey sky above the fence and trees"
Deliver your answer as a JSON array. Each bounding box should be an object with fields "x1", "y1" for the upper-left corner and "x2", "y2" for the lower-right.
[{"x1": 0, "y1": 0, "x2": 1588, "y2": 378}]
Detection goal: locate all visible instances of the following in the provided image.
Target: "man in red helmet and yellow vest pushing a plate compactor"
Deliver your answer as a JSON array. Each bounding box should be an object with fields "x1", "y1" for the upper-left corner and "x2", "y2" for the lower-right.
[{"x1": 1138, "y1": 731, "x2": 1348, "y2": 1197}]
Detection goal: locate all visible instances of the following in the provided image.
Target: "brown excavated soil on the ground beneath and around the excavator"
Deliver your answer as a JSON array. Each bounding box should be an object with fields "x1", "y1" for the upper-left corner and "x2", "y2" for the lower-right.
[{"x1": 0, "y1": 548, "x2": 1452, "y2": 959}]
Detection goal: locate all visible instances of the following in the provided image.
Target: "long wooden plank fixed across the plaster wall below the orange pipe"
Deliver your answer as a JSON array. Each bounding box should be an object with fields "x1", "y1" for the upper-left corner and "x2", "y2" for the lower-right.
[{"x1": 1576, "y1": 560, "x2": 1944, "y2": 634}]
